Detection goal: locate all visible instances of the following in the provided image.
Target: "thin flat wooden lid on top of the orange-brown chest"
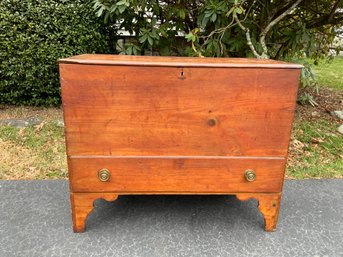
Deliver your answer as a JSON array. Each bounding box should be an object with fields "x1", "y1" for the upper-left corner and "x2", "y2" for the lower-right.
[{"x1": 59, "y1": 54, "x2": 303, "y2": 69}]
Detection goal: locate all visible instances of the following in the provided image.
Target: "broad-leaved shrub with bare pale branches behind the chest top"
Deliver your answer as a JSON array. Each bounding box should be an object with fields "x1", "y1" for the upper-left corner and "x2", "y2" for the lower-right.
[{"x1": 94, "y1": 0, "x2": 343, "y2": 59}]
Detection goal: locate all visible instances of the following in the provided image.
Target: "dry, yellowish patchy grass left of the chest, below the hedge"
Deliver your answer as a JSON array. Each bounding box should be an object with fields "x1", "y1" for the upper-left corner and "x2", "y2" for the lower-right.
[{"x1": 0, "y1": 107, "x2": 67, "y2": 179}]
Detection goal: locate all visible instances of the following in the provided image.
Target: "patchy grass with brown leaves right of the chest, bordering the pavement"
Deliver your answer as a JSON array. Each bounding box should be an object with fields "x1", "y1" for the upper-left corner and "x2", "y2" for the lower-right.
[{"x1": 286, "y1": 118, "x2": 343, "y2": 179}]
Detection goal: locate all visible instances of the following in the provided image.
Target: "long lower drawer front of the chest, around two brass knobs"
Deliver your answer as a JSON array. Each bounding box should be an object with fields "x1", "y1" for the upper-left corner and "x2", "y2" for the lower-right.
[{"x1": 68, "y1": 157, "x2": 285, "y2": 194}]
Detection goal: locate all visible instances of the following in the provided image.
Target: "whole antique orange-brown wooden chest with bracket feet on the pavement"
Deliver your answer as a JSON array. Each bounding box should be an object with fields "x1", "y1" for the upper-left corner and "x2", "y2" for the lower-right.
[{"x1": 59, "y1": 55, "x2": 302, "y2": 232}]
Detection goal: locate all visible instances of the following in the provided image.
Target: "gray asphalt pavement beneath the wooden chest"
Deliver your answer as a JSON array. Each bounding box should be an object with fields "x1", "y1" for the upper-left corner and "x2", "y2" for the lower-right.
[{"x1": 0, "y1": 180, "x2": 343, "y2": 257}]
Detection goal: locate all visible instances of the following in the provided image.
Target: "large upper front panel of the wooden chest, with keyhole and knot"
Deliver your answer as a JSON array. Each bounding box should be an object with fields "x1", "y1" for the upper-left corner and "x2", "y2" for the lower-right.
[{"x1": 60, "y1": 64, "x2": 299, "y2": 157}]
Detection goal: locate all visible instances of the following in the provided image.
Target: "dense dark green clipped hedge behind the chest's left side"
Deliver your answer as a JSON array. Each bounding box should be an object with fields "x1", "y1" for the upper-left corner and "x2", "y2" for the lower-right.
[{"x1": 0, "y1": 0, "x2": 109, "y2": 105}]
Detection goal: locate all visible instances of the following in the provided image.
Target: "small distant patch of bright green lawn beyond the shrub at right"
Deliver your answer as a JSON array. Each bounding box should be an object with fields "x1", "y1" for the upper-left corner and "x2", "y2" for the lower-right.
[{"x1": 313, "y1": 57, "x2": 343, "y2": 90}]
